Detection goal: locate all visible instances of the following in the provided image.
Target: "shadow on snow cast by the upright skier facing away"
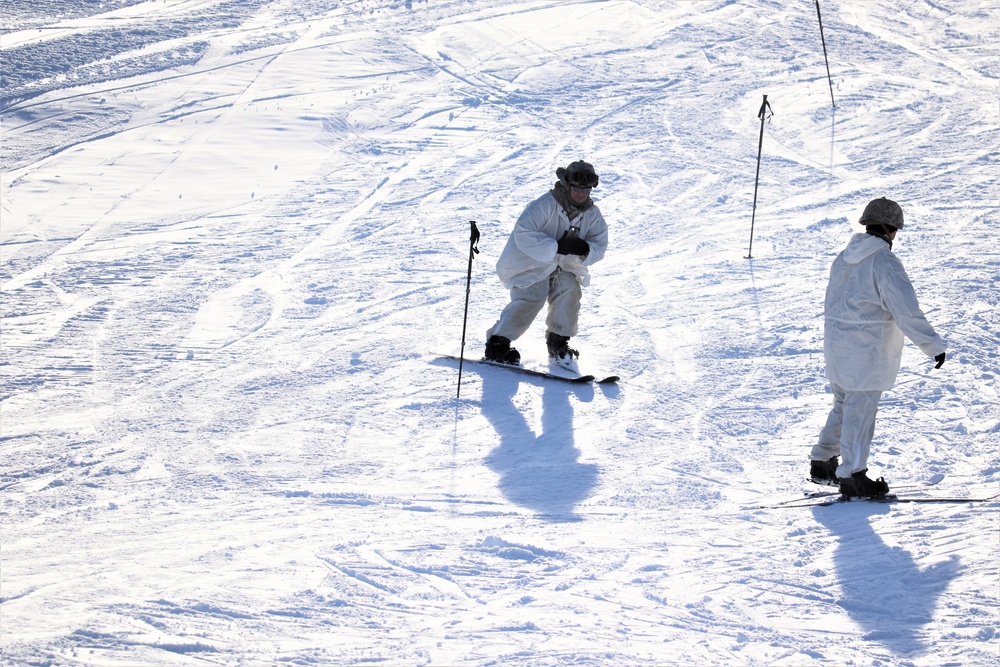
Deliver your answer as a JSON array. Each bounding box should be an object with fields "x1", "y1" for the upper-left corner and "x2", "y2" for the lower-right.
[{"x1": 813, "y1": 503, "x2": 960, "y2": 657}]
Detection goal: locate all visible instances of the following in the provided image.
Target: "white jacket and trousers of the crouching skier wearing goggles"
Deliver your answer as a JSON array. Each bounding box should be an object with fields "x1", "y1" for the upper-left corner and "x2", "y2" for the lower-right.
[{"x1": 487, "y1": 186, "x2": 608, "y2": 340}]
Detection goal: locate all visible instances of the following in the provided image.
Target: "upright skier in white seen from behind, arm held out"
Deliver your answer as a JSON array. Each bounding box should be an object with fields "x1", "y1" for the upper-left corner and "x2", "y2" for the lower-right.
[{"x1": 810, "y1": 197, "x2": 946, "y2": 498}]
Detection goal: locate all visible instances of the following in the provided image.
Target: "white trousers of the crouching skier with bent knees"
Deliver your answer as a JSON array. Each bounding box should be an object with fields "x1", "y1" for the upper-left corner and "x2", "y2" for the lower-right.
[{"x1": 486, "y1": 269, "x2": 583, "y2": 340}]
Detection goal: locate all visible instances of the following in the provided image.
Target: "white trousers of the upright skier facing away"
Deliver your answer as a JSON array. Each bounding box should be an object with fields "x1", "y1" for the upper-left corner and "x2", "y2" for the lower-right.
[{"x1": 810, "y1": 383, "x2": 882, "y2": 477}]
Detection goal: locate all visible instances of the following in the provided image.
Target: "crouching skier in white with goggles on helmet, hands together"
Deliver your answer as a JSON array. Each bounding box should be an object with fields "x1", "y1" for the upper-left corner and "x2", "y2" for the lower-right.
[{"x1": 485, "y1": 160, "x2": 608, "y2": 370}]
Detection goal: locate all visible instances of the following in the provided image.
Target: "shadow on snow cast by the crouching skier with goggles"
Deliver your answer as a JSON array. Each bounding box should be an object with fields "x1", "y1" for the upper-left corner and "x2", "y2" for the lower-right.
[{"x1": 482, "y1": 371, "x2": 599, "y2": 521}]
